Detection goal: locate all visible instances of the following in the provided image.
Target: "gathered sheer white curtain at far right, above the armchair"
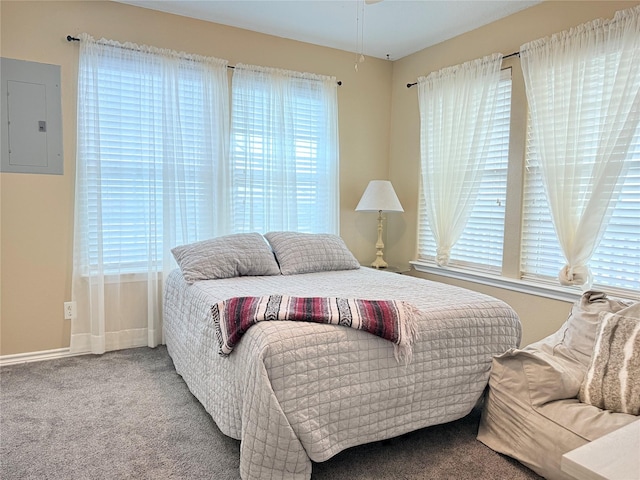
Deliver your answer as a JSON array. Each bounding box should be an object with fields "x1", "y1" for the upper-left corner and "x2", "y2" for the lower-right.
[{"x1": 520, "y1": 6, "x2": 640, "y2": 289}]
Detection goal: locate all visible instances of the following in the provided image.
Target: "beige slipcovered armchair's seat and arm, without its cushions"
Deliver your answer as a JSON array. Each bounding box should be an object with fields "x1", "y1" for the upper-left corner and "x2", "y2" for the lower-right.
[{"x1": 478, "y1": 338, "x2": 638, "y2": 480}]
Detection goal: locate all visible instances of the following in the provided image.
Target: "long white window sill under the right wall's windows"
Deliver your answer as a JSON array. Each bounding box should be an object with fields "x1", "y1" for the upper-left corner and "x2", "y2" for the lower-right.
[{"x1": 409, "y1": 260, "x2": 582, "y2": 303}]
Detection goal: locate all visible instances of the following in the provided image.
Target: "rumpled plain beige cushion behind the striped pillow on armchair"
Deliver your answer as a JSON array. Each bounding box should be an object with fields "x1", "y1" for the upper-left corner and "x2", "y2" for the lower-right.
[{"x1": 561, "y1": 291, "x2": 631, "y2": 366}]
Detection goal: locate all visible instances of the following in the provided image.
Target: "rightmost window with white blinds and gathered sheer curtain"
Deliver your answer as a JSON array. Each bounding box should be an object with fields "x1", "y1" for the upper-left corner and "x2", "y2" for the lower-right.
[{"x1": 521, "y1": 8, "x2": 640, "y2": 293}]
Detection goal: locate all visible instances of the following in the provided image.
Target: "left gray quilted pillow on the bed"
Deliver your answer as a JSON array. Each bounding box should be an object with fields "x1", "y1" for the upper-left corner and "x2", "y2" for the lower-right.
[{"x1": 171, "y1": 233, "x2": 280, "y2": 283}]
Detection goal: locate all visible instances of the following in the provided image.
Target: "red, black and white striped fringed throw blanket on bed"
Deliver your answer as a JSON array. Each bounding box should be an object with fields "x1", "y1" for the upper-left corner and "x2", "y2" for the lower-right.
[{"x1": 211, "y1": 295, "x2": 417, "y2": 363}]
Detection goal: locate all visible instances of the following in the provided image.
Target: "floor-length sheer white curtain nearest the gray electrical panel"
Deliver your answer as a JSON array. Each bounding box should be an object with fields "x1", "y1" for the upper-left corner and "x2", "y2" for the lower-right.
[{"x1": 71, "y1": 34, "x2": 229, "y2": 353}]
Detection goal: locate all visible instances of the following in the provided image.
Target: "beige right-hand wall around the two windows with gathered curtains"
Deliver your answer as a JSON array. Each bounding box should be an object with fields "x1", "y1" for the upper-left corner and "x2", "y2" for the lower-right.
[{"x1": 386, "y1": 1, "x2": 638, "y2": 345}]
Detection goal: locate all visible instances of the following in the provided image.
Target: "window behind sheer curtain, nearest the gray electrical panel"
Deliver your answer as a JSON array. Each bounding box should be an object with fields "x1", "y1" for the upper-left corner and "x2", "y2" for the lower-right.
[{"x1": 77, "y1": 41, "x2": 228, "y2": 274}]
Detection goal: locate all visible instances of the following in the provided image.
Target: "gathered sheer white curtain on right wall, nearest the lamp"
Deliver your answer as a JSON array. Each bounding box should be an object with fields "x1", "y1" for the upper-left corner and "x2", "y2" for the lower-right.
[{"x1": 418, "y1": 54, "x2": 502, "y2": 266}]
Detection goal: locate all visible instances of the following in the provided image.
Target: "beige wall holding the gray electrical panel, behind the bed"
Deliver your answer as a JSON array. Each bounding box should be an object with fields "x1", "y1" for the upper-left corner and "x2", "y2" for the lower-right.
[{"x1": 0, "y1": 1, "x2": 393, "y2": 355}]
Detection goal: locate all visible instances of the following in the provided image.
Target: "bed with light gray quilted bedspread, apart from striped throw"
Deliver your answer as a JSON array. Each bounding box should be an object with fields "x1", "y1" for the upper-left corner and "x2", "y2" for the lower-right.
[{"x1": 163, "y1": 232, "x2": 521, "y2": 480}]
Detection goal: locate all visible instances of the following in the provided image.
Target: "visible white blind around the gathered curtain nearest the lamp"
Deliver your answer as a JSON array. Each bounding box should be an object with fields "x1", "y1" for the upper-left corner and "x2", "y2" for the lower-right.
[{"x1": 418, "y1": 68, "x2": 512, "y2": 274}]
